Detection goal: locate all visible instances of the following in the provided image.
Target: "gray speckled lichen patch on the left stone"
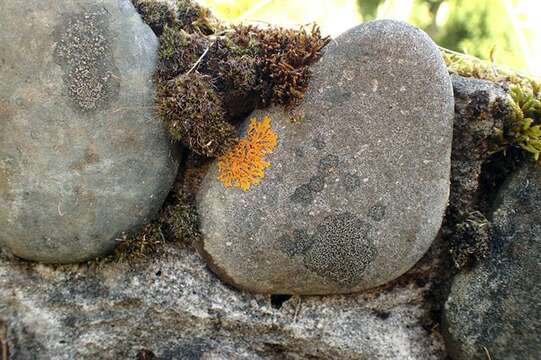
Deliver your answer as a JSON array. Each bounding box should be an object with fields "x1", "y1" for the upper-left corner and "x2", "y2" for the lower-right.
[{"x1": 54, "y1": 7, "x2": 120, "y2": 112}]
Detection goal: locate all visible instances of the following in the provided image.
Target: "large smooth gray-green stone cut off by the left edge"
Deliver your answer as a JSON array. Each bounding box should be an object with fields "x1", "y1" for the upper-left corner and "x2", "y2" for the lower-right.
[{"x1": 0, "y1": 0, "x2": 178, "y2": 263}]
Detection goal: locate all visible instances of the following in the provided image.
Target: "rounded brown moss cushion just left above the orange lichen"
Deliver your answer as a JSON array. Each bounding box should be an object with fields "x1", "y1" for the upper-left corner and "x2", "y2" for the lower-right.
[{"x1": 157, "y1": 73, "x2": 236, "y2": 157}]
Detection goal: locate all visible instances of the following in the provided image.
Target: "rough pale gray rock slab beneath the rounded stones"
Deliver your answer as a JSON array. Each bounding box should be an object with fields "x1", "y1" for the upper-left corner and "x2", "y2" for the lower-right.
[{"x1": 0, "y1": 239, "x2": 445, "y2": 360}]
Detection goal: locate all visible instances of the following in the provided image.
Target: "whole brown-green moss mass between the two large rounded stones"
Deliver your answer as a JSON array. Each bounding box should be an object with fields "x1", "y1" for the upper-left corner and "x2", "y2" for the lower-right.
[{"x1": 134, "y1": 0, "x2": 329, "y2": 157}]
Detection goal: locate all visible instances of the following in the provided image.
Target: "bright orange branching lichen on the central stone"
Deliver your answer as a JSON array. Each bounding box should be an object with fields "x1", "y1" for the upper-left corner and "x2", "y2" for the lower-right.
[{"x1": 218, "y1": 116, "x2": 278, "y2": 191}]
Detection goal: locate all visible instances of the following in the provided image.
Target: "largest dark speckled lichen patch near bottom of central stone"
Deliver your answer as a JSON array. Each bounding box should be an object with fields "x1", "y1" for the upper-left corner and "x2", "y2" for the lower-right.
[{"x1": 304, "y1": 212, "x2": 376, "y2": 287}]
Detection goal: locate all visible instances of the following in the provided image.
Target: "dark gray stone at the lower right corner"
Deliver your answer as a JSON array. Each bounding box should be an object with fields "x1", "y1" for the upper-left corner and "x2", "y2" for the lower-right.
[{"x1": 444, "y1": 165, "x2": 541, "y2": 360}]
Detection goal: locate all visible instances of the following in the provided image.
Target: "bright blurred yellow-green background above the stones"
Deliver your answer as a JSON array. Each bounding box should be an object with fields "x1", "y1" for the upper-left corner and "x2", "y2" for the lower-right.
[{"x1": 198, "y1": 0, "x2": 541, "y2": 76}]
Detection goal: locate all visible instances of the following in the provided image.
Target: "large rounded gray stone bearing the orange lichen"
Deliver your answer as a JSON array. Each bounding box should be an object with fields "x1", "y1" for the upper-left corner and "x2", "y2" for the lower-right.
[{"x1": 197, "y1": 20, "x2": 453, "y2": 294}]
